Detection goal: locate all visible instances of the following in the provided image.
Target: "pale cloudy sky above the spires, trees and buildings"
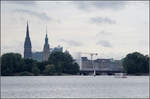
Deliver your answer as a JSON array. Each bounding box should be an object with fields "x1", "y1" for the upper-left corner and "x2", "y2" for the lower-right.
[{"x1": 1, "y1": 1, "x2": 149, "y2": 59}]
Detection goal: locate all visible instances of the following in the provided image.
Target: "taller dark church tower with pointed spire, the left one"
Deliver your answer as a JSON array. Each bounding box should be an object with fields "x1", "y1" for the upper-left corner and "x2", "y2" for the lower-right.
[{"x1": 24, "y1": 21, "x2": 32, "y2": 59}]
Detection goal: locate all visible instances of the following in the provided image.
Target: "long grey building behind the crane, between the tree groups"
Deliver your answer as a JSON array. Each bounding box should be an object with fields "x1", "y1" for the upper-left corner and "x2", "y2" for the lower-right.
[{"x1": 80, "y1": 57, "x2": 123, "y2": 71}]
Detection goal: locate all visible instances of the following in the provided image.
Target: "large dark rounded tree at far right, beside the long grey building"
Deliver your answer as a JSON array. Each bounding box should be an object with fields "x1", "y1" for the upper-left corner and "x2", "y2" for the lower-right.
[{"x1": 123, "y1": 52, "x2": 149, "y2": 74}]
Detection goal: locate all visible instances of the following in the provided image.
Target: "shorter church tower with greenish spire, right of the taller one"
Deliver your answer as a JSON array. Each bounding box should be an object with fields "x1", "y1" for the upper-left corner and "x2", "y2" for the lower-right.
[{"x1": 43, "y1": 28, "x2": 50, "y2": 61}]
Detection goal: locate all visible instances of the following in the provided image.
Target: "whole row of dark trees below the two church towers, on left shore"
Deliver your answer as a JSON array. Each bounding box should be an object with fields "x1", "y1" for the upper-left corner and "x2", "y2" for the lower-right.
[{"x1": 1, "y1": 52, "x2": 79, "y2": 76}]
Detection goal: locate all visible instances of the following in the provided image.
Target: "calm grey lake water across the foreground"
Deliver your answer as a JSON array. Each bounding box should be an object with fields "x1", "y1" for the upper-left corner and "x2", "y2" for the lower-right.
[{"x1": 1, "y1": 76, "x2": 149, "y2": 98}]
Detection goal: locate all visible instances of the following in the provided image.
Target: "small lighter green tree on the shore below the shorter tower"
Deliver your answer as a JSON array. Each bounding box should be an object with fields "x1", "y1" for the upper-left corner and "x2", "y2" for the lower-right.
[{"x1": 44, "y1": 64, "x2": 56, "y2": 75}]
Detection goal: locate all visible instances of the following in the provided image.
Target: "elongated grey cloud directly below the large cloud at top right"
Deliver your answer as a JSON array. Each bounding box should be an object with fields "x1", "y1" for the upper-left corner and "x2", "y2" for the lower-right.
[{"x1": 90, "y1": 17, "x2": 116, "y2": 24}]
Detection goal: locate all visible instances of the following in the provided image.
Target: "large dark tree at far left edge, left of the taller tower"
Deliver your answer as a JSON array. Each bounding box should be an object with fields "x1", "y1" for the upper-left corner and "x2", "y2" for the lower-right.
[{"x1": 1, "y1": 53, "x2": 23, "y2": 76}]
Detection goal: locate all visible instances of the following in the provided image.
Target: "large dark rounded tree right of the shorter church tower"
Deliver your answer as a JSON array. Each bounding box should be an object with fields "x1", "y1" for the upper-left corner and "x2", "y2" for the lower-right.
[{"x1": 48, "y1": 52, "x2": 79, "y2": 74}]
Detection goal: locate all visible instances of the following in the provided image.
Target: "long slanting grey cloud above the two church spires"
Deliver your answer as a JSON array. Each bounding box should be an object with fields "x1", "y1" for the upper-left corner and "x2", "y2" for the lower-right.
[{"x1": 14, "y1": 9, "x2": 51, "y2": 21}]
